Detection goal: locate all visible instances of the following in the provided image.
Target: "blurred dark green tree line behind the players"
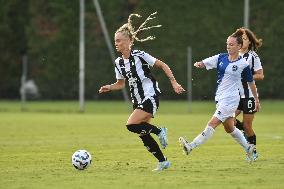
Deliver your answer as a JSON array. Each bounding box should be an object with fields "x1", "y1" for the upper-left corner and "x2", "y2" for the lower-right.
[{"x1": 0, "y1": 0, "x2": 284, "y2": 99}]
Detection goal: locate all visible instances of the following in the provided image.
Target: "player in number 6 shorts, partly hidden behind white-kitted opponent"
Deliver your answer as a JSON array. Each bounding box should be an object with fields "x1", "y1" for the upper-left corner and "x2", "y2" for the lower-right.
[{"x1": 236, "y1": 28, "x2": 264, "y2": 161}]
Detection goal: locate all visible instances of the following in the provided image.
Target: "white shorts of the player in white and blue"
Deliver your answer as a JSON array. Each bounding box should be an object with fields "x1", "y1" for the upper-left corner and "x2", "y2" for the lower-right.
[{"x1": 213, "y1": 97, "x2": 240, "y2": 122}]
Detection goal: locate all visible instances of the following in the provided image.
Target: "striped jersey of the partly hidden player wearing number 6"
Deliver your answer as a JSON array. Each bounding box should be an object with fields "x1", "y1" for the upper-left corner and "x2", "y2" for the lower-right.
[{"x1": 240, "y1": 50, "x2": 262, "y2": 98}]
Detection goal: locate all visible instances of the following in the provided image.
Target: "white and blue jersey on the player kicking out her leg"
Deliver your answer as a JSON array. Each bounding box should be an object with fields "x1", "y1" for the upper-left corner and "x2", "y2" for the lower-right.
[{"x1": 202, "y1": 53, "x2": 253, "y2": 102}]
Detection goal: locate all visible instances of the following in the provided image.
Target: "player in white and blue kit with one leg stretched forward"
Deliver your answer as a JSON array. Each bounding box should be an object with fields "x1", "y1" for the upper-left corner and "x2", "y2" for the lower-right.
[{"x1": 179, "y1": 31, "x2": 260, "y2": 162}]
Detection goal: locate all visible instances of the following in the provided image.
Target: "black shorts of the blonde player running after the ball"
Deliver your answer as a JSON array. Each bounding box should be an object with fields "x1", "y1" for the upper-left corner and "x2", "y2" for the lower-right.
[{"x1": 133, "y1": 96, "x2": 159, "y2": 117}]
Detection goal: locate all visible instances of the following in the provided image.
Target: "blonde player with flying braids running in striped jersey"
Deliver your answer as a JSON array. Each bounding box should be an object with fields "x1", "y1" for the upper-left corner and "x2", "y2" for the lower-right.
[{"x1": 99, "y1": 12, "x2": 184, "y2": 171}]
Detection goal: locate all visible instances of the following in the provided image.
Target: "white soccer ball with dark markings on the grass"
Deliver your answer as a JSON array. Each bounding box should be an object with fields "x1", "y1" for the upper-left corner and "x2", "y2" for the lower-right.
[{"x1": 72, "y1": 150, "x2": 92, "y2": 170}]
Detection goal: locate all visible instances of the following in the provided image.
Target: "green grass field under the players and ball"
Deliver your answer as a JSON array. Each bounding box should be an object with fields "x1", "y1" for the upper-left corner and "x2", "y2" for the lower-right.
[{"x1": 0, "y1": 101, "x2": 284, "y2": 189}]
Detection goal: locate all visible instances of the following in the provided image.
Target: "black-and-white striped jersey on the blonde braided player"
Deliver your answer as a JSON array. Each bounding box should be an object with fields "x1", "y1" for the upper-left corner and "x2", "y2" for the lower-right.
[{"x1": 115, "y1": 50, "x2": 161, "y2": 104}]
